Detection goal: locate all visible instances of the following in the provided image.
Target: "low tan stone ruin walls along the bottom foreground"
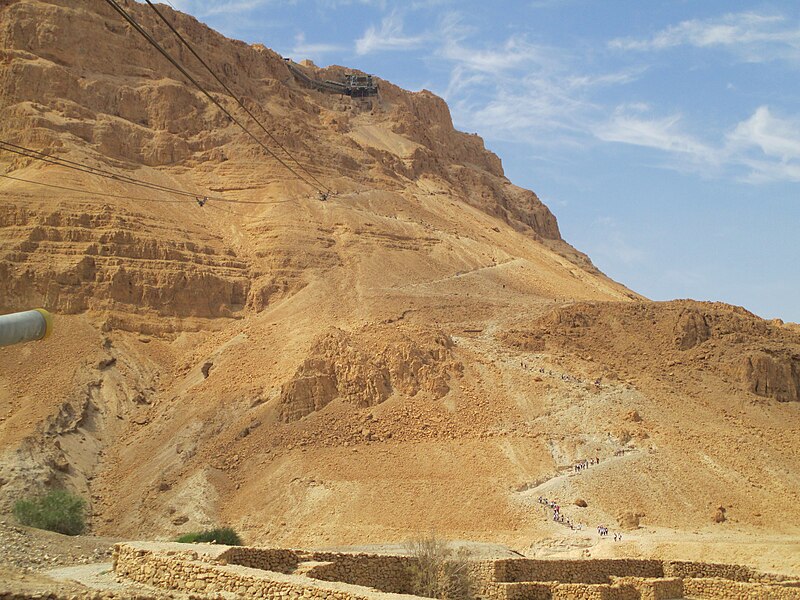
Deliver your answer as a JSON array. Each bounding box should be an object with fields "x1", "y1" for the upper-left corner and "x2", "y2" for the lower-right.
[{"x1": 114, "y1": 542, "x2": 800, "y2": 600}]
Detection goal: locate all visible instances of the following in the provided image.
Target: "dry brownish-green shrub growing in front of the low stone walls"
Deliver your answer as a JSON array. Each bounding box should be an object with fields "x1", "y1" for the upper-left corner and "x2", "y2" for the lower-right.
[{"x1": 406, "y1": 533, "x2": 476, "y2": 600}]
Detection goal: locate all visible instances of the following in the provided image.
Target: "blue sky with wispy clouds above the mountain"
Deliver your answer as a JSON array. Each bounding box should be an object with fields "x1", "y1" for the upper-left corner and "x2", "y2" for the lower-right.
[{"x1": 164, "y1": 0, "x2": 800, "y2": 322}]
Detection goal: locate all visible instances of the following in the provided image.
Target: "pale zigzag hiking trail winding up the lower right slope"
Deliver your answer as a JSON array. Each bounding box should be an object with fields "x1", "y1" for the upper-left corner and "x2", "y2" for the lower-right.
[{"x1": 454, "y1": 321, "x2": 655, "y2": 556}]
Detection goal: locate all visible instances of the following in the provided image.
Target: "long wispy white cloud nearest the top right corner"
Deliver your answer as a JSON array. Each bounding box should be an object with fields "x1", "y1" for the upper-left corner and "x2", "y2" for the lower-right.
[{"x1": 609, "y1": 12, "x2": 800, "y2": 62}]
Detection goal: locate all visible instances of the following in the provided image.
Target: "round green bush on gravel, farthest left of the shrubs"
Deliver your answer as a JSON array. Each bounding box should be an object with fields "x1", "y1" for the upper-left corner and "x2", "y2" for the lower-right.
[{"x1": 14, "y1": 490, "x2": 86, "y2": 535}]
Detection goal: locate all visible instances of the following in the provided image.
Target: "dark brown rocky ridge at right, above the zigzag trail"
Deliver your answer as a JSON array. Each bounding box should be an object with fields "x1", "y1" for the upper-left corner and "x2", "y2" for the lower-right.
[{"x1": 505, "y1": 301, "x2": 800, "y2": 404}]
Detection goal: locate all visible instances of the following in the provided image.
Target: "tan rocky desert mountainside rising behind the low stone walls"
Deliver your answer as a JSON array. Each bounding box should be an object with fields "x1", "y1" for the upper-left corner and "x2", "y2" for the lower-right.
[{"x1": 0, "y1": 0, "x2": 800, "y2": 570}]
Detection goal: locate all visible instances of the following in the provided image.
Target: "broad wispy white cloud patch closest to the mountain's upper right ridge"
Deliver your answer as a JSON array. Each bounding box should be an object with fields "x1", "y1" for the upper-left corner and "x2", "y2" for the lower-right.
[{"x1": 432, "y1": 12, "x2": 641, "y2": 147}]
